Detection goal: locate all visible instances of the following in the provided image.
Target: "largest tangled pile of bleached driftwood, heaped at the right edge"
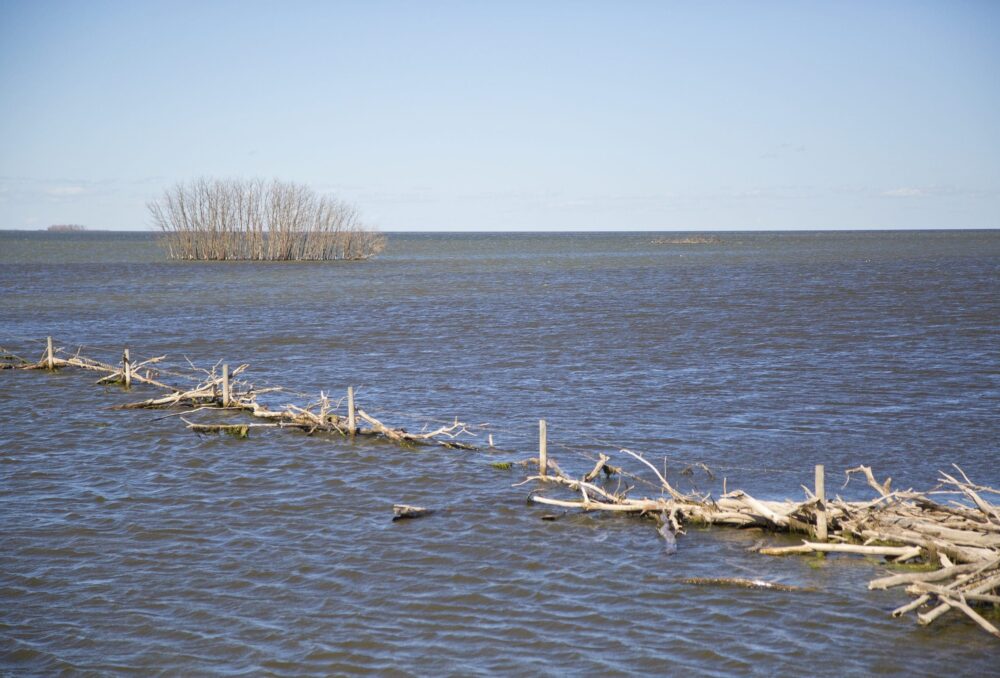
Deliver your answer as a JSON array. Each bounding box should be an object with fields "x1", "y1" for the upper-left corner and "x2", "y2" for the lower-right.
[{"x1": 520, "y1": 449, "x2": 1000, "y2": 638}]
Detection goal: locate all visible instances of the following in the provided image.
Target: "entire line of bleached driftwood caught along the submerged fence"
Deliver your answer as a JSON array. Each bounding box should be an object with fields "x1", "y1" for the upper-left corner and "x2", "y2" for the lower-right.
[{"x1": 0, "y1": 340, "x2": 1000, "y2": 638}]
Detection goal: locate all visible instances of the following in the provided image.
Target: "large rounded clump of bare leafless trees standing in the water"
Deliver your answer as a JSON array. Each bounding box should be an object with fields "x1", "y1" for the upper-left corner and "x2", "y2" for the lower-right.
[{"x1": 148, "y1": 179, "x2": 385, "y2": 261}]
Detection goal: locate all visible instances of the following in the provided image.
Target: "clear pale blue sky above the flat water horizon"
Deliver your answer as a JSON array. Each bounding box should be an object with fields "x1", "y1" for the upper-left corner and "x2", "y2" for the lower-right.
[{"x1": 0, "y1": 0, "x2": 1000, "y2": 231}]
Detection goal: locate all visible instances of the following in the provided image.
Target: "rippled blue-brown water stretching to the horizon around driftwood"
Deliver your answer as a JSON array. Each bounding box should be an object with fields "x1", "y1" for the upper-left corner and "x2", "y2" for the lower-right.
[{"x1": 0, "y1": 231, "x2": 1000, "y2": 676}]
